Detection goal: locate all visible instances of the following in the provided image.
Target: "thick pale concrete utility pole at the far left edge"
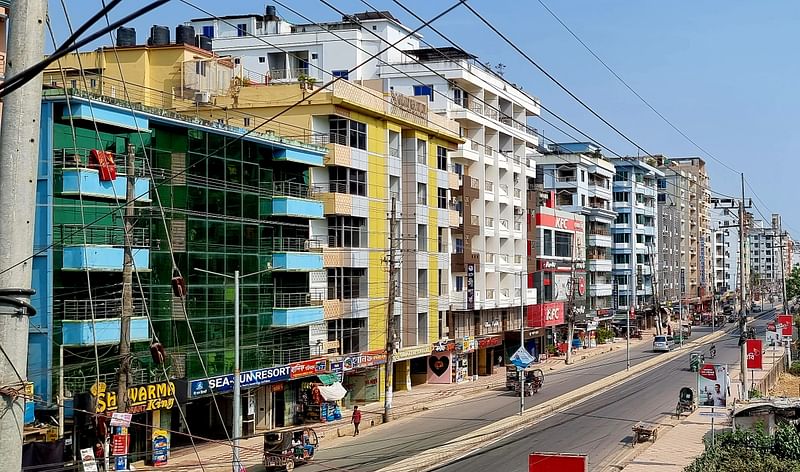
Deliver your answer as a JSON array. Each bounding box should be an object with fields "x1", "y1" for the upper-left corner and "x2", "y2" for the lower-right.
[{"x1": 0, "y1": 0, "x2": 47, "y2": 472}]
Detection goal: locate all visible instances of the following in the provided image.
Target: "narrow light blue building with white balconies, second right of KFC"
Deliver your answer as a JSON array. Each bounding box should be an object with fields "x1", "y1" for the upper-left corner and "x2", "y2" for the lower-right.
[{"x1": 611, "y1": 158, "x2": 664, "y2": 325}]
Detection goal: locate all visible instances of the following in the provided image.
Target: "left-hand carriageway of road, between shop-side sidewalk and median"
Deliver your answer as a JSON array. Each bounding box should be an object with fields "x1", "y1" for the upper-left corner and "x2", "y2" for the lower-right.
[{"x1": 249, "y1": 318, "x2": 735, "y2": 472}]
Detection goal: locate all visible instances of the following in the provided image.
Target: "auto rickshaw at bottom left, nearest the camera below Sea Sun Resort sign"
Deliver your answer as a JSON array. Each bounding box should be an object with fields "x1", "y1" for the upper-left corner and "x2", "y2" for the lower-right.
[{"x1": 264, "y1": 427, "x2": 319, "y2": 471}]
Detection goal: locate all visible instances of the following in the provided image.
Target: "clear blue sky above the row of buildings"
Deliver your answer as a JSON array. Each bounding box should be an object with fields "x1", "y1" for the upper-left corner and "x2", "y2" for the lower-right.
[{"x1": 46, "y1": 0, "x2": 800, "y2": 238}]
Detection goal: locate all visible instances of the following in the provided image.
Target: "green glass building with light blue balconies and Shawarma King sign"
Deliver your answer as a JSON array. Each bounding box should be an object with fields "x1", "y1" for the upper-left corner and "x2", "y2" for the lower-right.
[{"x1": 28, "y1": 85, "x2": 327, "y2": 457}]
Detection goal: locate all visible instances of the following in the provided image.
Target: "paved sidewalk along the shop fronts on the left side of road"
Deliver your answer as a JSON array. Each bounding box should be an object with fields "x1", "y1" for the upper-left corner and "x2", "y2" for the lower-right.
[{"x1": 134, "y1": 332, "x2": 652, "y2": 472}]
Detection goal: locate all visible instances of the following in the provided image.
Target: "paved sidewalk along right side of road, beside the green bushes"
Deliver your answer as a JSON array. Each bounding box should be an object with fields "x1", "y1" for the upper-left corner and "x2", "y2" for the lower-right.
[{"x1": 622, "y1": 348, "x2": 783, "y2": 472}]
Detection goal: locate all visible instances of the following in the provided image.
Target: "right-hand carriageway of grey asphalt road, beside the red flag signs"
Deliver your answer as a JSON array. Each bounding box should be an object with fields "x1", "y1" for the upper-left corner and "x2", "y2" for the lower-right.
[{"x1": 436, "y1": 310, "x2": 774, "y2": 472}]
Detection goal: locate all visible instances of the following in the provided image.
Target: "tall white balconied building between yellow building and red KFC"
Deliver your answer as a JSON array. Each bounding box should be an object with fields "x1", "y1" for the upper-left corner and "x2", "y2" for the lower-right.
[{"x1": 190, "y1": 8, "x2": 540, "y2": 373}]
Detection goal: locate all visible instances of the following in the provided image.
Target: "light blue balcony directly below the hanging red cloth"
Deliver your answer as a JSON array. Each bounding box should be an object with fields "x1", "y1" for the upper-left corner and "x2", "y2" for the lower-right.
[{"x1": 61, "y1": 169, "x2": 151, "y2": 203}]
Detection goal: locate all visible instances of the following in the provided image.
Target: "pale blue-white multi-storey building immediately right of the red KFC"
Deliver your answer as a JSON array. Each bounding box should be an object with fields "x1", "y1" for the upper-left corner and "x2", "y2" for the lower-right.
[{"x1": 537, "y1": 143, "x2": 616, "y2": 319}]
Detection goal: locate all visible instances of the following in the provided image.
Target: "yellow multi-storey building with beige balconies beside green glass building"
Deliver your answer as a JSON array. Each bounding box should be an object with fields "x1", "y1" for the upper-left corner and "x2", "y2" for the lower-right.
[{"x1": 185, "y1": 80, "x2": 463, "y2": 401}]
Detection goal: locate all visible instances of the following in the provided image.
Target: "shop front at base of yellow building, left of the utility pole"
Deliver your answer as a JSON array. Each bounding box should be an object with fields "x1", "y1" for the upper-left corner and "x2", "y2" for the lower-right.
[{"x1": 331, "y1": 350, "x2": 386, "y2": 408}]
